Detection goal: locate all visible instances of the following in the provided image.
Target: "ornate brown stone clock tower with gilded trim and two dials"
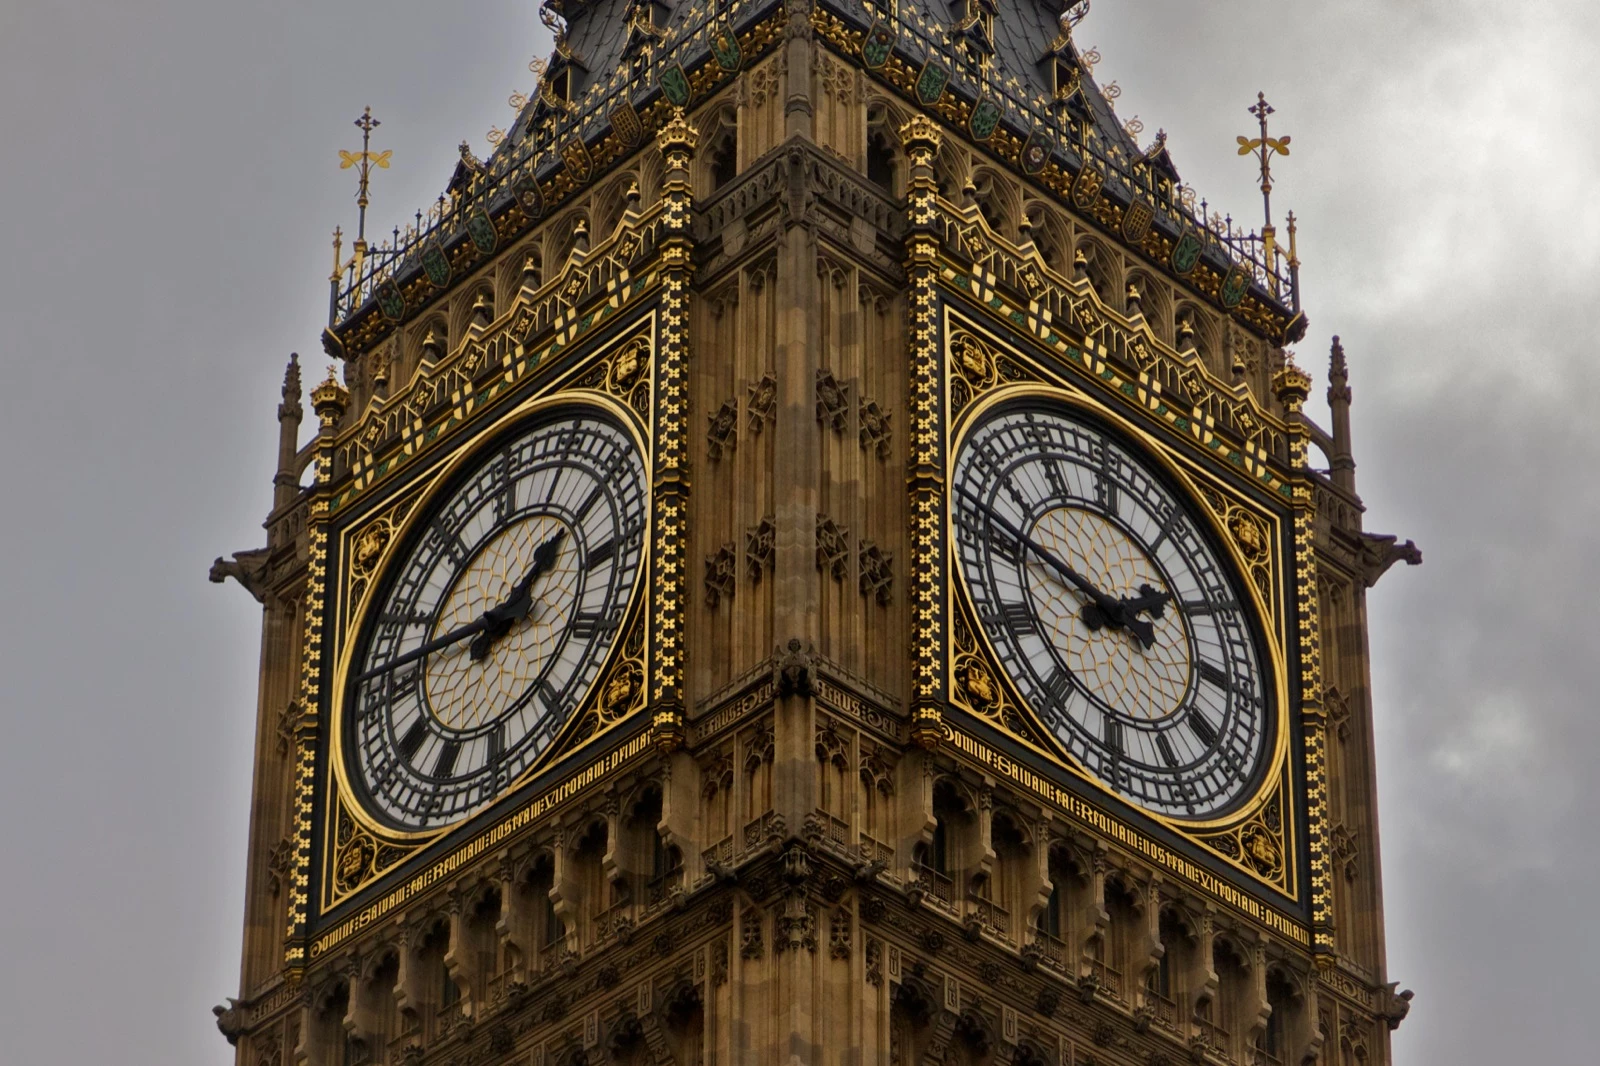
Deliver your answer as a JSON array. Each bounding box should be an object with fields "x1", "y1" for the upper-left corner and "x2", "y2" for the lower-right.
[{"x1": 213, "y1": 0, "x2": 1421, "y2": 1066}]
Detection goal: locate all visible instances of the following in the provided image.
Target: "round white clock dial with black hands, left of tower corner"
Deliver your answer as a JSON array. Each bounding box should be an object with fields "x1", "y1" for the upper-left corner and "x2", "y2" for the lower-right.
[{"x1": 344, "y1": 408, "x2": 648, "y2": 831}]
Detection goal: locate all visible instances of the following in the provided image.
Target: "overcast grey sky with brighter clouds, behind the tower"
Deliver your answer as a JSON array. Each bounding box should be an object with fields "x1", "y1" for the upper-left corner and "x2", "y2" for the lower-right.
[{"x1": 0, "y1": 0, "x2": 1600, "y2": 1066}]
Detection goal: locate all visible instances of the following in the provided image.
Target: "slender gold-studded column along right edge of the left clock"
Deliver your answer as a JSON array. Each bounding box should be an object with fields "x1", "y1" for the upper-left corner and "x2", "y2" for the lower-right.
[{"x1": 650, "y1": 110, "x2": 698, "y2": 752}]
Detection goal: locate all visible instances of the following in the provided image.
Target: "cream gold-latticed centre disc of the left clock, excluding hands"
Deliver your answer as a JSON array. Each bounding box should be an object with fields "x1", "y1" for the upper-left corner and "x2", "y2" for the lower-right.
[{"x1": 422, "y1": 515, "x2": 579, "y2": 730}]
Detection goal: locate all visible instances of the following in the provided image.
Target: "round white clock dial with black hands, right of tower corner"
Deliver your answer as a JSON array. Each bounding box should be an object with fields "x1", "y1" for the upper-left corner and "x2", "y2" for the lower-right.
[{"x1": 952, "y1": 400, "x2": 1270, "y2": 818}]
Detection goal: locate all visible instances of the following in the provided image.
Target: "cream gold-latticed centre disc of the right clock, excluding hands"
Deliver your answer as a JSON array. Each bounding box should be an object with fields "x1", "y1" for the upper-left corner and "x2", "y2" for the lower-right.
[{"x1": 1027, "y1": 507, "x2": 1190, "y2": 722}]
